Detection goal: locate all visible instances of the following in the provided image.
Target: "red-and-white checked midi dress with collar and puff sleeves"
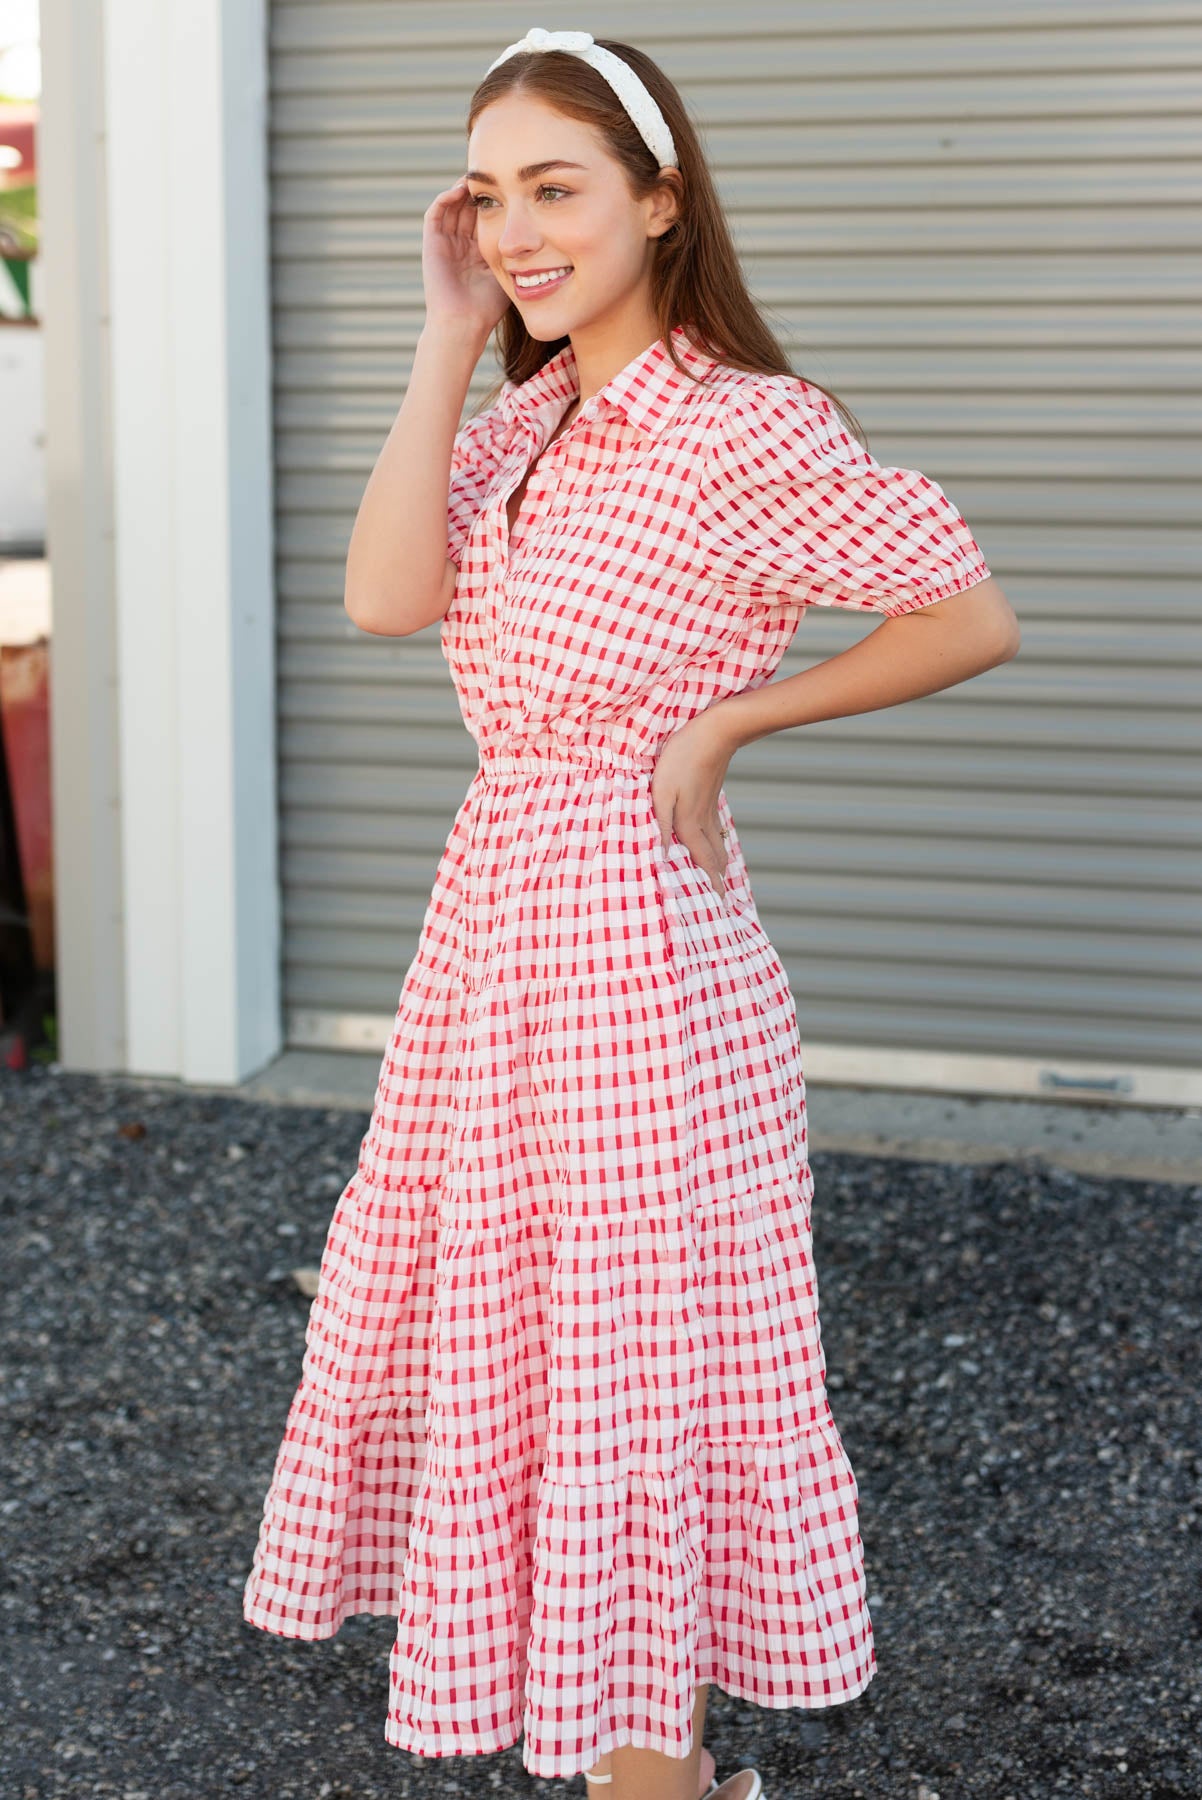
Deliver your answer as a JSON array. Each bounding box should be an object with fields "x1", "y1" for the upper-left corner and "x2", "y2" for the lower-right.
[{"x1": 243, "y1": 329, "x2": 988, "y2": 1777}]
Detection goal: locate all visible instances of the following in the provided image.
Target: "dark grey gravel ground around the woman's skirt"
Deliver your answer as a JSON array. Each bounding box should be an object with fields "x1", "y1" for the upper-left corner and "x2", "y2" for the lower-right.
[{"x1": 0, "y1": 1067, "x2": 1202, "y2": 1800}]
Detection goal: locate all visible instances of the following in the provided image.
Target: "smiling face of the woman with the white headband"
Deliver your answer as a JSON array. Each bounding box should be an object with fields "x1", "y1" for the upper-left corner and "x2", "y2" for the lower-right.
[{"x1": 468, "y1": 94, "x2": 675, "y2": 342}]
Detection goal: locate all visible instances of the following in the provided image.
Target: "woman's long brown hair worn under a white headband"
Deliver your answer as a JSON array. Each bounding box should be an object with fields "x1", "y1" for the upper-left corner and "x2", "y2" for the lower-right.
[{"x1": 468, "y1": 38, "x2": 864, "y2": 439}]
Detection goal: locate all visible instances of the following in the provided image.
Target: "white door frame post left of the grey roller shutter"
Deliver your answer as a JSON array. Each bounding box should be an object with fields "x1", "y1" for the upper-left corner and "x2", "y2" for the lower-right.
[{"x1": 41, "y1": 0, "x2": 283, "y2": 1084}]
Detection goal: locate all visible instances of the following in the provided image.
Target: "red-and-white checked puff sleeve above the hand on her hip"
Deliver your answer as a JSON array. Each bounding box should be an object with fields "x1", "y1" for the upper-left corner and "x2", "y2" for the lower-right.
[{"x1": 698, "y1": 376, "x2": 990, "y2": 617}]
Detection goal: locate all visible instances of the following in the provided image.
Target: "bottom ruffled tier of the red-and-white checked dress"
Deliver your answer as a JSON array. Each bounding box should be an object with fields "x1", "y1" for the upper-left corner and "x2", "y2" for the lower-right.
[{"x1": 243, "y1": 1395, "x2": 876, "y2": 1778}]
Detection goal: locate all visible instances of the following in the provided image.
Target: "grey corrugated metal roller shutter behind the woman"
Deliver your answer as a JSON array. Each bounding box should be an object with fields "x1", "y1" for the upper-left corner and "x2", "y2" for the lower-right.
[{"x1": 272, "y1": 0, "x2": 1202, "y2": 1100}]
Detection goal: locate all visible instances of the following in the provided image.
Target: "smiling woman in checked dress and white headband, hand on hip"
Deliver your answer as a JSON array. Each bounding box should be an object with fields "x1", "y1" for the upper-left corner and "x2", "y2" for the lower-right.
[{"x1": 245, "y1": 32, "x2": 1018, "y2": 1800}]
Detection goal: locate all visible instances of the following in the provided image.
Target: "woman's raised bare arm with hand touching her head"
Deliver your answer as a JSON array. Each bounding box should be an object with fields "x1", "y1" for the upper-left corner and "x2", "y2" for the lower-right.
[{"x1": 344, "y1": 175, "x2": 509, "y2": 637}]
